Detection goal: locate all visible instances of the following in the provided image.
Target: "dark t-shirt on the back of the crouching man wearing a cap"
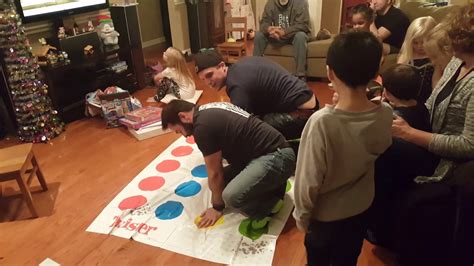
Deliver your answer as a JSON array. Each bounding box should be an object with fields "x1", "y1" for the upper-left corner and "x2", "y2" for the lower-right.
[{"x1": 226, "y1": 56, "x2": 313, "y2": 115}]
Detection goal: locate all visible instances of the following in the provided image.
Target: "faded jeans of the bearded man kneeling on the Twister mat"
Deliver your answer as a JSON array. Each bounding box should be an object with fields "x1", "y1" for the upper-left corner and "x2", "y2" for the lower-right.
[{"x1": 222, "y1": 148, "x2": 296, "y2": 219}]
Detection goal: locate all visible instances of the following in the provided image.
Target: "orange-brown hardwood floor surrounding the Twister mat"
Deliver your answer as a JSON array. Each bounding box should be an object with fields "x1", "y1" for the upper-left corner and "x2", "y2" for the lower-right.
[{"x1": 0, "y1": 44, "x2": 394, "y2": 265}]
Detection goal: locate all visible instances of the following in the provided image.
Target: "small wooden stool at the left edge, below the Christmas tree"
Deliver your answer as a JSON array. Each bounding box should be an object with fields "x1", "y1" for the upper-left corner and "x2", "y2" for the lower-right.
[{"x1": 0, "y1": 143, "x2": 48, "y2": 218}]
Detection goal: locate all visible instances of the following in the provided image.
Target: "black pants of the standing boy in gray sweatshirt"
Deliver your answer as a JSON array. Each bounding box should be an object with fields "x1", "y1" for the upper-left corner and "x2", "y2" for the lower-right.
[{"x1": 304, "y1": 211, "x2": 368, "y2": 266}]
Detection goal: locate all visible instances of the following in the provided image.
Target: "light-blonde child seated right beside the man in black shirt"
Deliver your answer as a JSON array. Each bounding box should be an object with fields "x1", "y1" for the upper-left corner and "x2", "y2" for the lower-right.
[{"x1": 397, "y1": 16, "x2": 436, "y2": 103}]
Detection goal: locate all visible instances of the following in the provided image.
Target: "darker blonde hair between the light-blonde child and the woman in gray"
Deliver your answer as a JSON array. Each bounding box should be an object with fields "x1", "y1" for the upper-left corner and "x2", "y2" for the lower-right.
[{"x1": 423, "y1": 23, "x2": 453, "y2": 68}]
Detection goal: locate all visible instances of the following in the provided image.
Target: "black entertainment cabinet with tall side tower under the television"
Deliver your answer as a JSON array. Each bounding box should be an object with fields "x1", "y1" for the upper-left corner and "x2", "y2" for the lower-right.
[{"x1": 42, "y1": 5, "x2": 146, "y2": 122}]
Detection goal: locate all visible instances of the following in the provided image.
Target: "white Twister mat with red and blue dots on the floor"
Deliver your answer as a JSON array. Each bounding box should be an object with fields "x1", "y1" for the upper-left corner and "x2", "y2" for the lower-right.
[{"x1": 87, "y1": 137, "x2": 293, "y2": 265}]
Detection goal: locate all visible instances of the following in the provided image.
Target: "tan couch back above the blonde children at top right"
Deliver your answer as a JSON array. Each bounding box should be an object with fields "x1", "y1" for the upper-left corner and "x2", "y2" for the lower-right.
[{"x1": 400, "y1": 2, "x2": 459, "y2": 22}]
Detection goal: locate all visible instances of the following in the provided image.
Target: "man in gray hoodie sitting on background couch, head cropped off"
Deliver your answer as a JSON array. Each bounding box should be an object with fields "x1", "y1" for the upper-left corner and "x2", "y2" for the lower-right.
[{"x1": 253, "y1": 0, "x2": 311, "y2": 79}]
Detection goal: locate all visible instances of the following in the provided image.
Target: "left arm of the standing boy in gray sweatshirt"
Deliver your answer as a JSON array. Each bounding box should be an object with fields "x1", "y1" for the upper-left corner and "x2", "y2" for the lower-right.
[{"x1": 293, "y1": 118, "x2": 327, "y2": 232}]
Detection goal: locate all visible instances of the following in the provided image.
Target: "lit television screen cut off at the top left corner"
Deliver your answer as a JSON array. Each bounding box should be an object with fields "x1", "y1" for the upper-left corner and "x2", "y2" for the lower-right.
[{"x1": 16, "y1": 0, "x2": 108, "y2": 21}]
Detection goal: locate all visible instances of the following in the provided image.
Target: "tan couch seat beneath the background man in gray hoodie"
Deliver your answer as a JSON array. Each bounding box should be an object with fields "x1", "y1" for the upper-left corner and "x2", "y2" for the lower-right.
[{"x1": 265, "y1": 39, "x2": 332, "y2": 58}]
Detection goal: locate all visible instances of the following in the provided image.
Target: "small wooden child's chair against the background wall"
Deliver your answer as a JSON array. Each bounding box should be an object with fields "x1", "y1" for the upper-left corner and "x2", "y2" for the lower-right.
[{"x1": 217, "y1": 17, "x2": 247, "y2": 63}]
